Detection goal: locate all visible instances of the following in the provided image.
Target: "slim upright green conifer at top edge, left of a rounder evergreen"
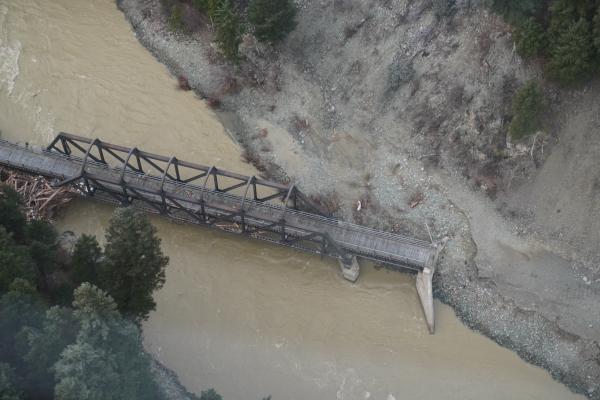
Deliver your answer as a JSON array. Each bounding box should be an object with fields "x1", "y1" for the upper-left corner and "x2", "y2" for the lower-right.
[{"x1": 215, "y1": 0, "x2": 243, "y2": 63}]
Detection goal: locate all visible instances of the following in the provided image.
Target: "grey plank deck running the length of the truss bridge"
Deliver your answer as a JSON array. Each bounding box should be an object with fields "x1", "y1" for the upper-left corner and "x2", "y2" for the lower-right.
[{"x1": 0, "y1": 141, "x2": 436, "y2": 271}]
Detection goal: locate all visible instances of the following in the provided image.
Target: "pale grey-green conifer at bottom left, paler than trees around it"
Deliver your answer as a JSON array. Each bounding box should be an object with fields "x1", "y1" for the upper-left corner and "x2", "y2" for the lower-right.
[{"x1": 54, "y1": 283, "x2": 160, "y2": 400}]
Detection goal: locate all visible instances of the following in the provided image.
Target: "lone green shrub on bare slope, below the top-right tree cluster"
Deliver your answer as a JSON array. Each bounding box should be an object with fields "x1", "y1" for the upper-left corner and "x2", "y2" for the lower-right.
[{"x1": 508, "y1": 81, "x2": 544, "y2": 140}]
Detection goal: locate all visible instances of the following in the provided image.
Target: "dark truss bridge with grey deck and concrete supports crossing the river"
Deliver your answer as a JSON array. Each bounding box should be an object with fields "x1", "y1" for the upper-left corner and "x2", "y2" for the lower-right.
[{"x1": 0, "y1": 132, "x2": 443, "y2": 333}]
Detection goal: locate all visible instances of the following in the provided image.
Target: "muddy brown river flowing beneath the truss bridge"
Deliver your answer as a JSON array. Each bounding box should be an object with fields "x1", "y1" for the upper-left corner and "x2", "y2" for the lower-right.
[{"x1": 0, "y1": 0, "x2": 579, "y2": 400}]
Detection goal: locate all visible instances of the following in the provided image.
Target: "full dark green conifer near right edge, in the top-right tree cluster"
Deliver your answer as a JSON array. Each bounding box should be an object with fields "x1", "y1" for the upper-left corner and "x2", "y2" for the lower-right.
[{"x1": 547, "y1": 18, "x2": 593, "y2": 84}]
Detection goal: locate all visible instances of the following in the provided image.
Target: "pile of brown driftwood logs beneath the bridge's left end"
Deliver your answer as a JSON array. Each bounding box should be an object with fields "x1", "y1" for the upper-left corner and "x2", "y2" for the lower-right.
[{"x1": 0, "y1": 167, "x2": 77, "y2": 220}]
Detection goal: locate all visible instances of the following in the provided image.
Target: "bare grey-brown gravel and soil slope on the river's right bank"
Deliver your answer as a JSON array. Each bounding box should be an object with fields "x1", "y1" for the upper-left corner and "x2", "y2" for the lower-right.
[{"x1": 117, "y1": 0, "x2": 600, "y2": 399}]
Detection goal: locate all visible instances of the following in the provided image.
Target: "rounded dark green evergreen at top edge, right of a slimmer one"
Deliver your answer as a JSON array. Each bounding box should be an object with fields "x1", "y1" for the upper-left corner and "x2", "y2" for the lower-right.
[{"x1": 248, "y1": 0, "x2": 296, "y2": 43}]
